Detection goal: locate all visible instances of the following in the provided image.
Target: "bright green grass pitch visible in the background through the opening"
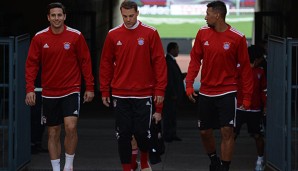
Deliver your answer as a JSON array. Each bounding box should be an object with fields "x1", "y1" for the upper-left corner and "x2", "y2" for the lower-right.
[{"x1": 139, "y1": 14, "x2": 254, "y2": 38}]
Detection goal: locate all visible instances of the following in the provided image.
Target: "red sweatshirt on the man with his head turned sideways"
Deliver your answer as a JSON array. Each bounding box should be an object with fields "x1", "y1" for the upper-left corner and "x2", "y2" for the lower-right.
[{"x1": 186, "y1": 25, "x2": 253, "y2": 100}]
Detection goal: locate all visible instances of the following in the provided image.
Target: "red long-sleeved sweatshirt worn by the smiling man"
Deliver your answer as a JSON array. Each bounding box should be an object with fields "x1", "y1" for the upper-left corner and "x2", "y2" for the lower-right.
[{"x1": 25, "y1": 26, "x2": 94, "y2": 97}]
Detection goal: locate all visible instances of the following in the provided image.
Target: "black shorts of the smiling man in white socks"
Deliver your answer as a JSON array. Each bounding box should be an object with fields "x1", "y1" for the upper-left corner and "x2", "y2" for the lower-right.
[{"x1": 41, "y1": 93, "x2": 80, "y2": 126}]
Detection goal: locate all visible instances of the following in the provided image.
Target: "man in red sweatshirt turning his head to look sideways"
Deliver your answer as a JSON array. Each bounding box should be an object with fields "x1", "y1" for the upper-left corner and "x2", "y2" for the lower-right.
[{"x1": 186, "y1": 1, "x2": 252, "y2": 171}]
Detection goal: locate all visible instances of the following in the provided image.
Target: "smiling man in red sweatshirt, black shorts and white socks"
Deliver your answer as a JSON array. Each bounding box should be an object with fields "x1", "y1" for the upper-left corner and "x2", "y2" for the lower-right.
[{"x1": 25, "y1": 3, "x2": 94, "y2": 171}]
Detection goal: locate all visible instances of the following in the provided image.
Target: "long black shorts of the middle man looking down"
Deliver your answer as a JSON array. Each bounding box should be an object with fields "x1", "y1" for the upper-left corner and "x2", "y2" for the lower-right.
[{"x1": 113, "y1": 97, "x2": 154, "y2": 150}]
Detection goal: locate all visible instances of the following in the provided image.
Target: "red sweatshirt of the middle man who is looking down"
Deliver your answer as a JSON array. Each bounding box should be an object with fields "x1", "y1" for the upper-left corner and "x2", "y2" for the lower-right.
[{"x1": 99, "y1": 21, "x2": 167, "y2": 112}]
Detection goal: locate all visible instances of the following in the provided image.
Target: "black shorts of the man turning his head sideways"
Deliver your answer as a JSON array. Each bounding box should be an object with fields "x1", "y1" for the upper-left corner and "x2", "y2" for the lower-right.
[{"x1": 198, "y1": 93, "x2": 236, "y2": 130}]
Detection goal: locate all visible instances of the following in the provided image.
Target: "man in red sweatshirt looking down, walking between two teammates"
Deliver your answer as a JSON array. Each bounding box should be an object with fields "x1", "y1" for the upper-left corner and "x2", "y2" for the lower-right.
[{"x1": 99, "y1": 0, "x2": 167, "y2": 171}]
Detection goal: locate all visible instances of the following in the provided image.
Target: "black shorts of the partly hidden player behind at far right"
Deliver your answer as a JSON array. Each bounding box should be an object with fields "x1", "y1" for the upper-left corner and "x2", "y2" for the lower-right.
[{"x1": 235, "y1": 110, "x2": 263, "y2": 135}]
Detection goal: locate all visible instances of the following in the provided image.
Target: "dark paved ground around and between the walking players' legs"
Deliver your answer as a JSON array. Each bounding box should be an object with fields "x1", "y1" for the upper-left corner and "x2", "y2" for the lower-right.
[{"x1": 25, "y1": 101, "x2": 256, "y2": 171}]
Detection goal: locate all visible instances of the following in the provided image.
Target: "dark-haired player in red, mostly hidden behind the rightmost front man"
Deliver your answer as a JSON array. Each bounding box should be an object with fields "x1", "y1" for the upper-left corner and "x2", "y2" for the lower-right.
[{"x1": 235, "y1": 45, "x2": 267, "y2": 171}]
